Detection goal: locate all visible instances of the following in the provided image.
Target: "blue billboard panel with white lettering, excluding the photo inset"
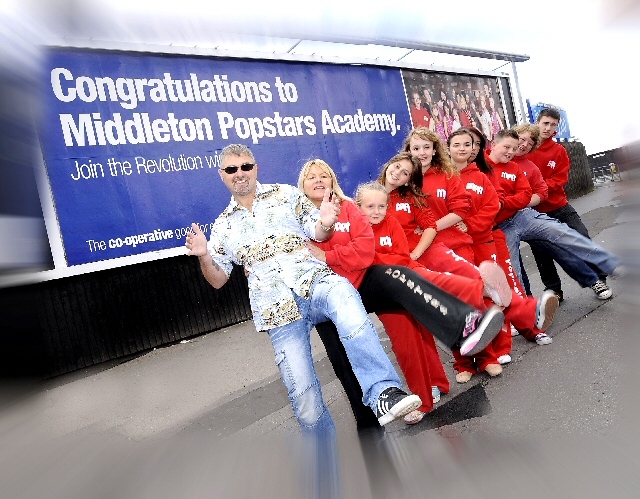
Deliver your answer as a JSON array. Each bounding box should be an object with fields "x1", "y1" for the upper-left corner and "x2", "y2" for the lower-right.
[{"x1": 38, "y1": 48, "x2": 411, "y2": 266}]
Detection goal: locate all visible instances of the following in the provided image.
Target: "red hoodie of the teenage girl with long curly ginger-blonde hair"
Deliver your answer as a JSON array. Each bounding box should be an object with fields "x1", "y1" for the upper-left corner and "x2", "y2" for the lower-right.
[{"x1": 422, "y1": 167, "x2": 473, "y2": 251}]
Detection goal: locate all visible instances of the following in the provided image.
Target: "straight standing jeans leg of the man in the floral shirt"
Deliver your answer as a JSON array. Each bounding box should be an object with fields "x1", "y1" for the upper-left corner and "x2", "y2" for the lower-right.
[{"x1": 269, "y1": 313, "x2": 335, "y2": 436}]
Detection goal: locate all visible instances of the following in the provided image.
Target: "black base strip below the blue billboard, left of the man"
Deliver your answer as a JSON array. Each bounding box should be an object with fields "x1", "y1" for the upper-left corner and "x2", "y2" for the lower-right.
[{"x1": 0, "y1": 256, "x2": 251, "y2": 380}]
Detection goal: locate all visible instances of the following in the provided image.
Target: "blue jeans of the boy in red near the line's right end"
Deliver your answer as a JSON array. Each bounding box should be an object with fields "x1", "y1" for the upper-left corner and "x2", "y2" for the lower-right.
[{"x1": 498, "y1": 208, "x2": 620, "y2": 286}]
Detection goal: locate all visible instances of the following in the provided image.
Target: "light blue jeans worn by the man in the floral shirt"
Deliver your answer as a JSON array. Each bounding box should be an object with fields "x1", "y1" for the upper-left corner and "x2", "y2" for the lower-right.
[{"x1": 269, "y1": 274, "x2": 402, "y2": 434}]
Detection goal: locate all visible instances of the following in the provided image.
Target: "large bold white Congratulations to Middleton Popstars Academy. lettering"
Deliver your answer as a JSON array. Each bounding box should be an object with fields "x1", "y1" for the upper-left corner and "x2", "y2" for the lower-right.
[{"x1": 51, "y1": 67, "x2": 400, "y2": 147}]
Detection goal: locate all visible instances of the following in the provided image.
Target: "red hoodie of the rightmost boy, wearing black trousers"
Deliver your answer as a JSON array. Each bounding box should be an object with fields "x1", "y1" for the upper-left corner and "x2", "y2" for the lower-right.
[{"x1": 526, "y1": 137, "x2": 571, "y2": 213}]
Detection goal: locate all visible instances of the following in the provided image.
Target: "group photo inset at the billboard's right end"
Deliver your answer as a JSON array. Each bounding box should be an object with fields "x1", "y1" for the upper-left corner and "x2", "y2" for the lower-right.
[{"x1": 402, "y1": 70, "x2": 509, "y2": 142}]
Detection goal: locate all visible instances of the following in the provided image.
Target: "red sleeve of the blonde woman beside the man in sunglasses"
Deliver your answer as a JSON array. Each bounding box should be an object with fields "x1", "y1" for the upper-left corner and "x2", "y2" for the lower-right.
[{"x1": 325, "y1": 201, "x2": 375, "y2": 271}]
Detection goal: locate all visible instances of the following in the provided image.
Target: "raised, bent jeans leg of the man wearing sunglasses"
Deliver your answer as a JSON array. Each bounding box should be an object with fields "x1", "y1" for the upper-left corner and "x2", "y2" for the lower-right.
[{"x1": 309, "y1": 275, "x2": 402, "y2": 411}]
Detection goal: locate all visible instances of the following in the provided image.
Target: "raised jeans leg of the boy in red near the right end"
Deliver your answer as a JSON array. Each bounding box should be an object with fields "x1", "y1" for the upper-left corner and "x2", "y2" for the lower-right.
[{"x1": 521, "y1": 208, "x2": 620, "y2": 275}]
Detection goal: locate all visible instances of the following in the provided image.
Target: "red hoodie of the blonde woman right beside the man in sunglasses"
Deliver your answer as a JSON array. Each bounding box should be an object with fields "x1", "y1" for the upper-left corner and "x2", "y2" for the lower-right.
[{"x1": 314, "y1": 197, "x2": 375, "y2": 288}]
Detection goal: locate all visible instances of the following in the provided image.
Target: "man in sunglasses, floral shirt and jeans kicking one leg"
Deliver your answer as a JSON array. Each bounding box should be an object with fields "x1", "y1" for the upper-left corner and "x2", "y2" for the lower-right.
[{"x1": 186, "y1": 144, "x2": 421, "y2": 435}]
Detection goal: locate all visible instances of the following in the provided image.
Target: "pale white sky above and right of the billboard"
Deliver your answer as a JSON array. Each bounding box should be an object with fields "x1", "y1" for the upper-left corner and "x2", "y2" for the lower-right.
[{"x1": 5, "y1": 0, "x2": 640, "y2": 153}]
